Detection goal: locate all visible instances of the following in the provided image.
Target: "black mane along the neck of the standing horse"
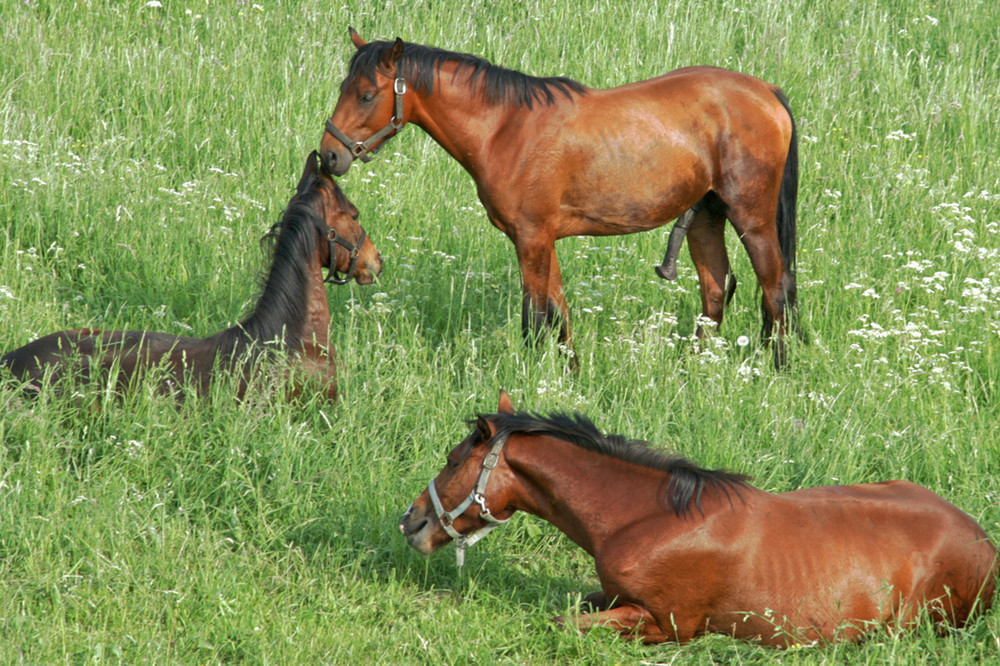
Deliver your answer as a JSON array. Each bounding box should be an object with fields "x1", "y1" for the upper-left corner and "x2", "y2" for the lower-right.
[{"x1": 348, "y1": 42, "x2": 586, "y2": 109}]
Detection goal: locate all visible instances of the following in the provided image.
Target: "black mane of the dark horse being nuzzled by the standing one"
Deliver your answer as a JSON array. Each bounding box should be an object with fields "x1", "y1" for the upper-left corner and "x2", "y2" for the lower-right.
[{"x1": 220, "y1": 179, "x2": 327, "y2": 355}]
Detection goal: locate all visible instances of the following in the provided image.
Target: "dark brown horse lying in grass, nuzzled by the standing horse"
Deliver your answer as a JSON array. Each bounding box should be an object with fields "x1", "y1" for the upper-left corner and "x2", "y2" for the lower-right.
[{"x1": 0, "y1": 151, "x2": 382, "y2": 400}]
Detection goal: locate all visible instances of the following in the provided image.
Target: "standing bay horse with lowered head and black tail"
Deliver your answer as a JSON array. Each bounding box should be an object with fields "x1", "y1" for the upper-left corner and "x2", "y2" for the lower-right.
[{"x1": 320, "y1": 28, "x2": 798, "y2": 368}]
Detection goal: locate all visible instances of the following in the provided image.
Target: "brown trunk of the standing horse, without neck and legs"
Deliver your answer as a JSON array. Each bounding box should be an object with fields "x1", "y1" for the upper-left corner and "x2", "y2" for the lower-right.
[{"x1": 508, "y1": 67, "x2": 793, "y2": 238}]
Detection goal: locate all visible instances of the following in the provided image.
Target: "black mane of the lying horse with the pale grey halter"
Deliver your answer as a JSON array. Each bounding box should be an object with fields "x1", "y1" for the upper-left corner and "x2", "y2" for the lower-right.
[{"x1": 483, "y1": 412, "x2": 750, "y2": 516}]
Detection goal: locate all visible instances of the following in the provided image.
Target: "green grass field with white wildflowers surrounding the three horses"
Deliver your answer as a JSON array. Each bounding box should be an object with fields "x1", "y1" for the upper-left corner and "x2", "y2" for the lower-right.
[{"x1": 0, "y1": 0, "x2": 1000, "y2": 664}]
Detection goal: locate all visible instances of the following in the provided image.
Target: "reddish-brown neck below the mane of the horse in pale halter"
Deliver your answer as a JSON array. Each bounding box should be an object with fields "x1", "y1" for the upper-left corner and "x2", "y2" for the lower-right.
[{"x1": 504, "y1": 435, "x2": 669, "y2": 555}]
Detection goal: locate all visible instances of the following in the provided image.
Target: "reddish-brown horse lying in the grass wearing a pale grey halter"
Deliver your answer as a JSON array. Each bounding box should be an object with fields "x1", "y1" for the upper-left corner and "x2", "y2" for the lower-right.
[{"x1": 400, "y1": 392, "x2": 998, "y2": 647}]
